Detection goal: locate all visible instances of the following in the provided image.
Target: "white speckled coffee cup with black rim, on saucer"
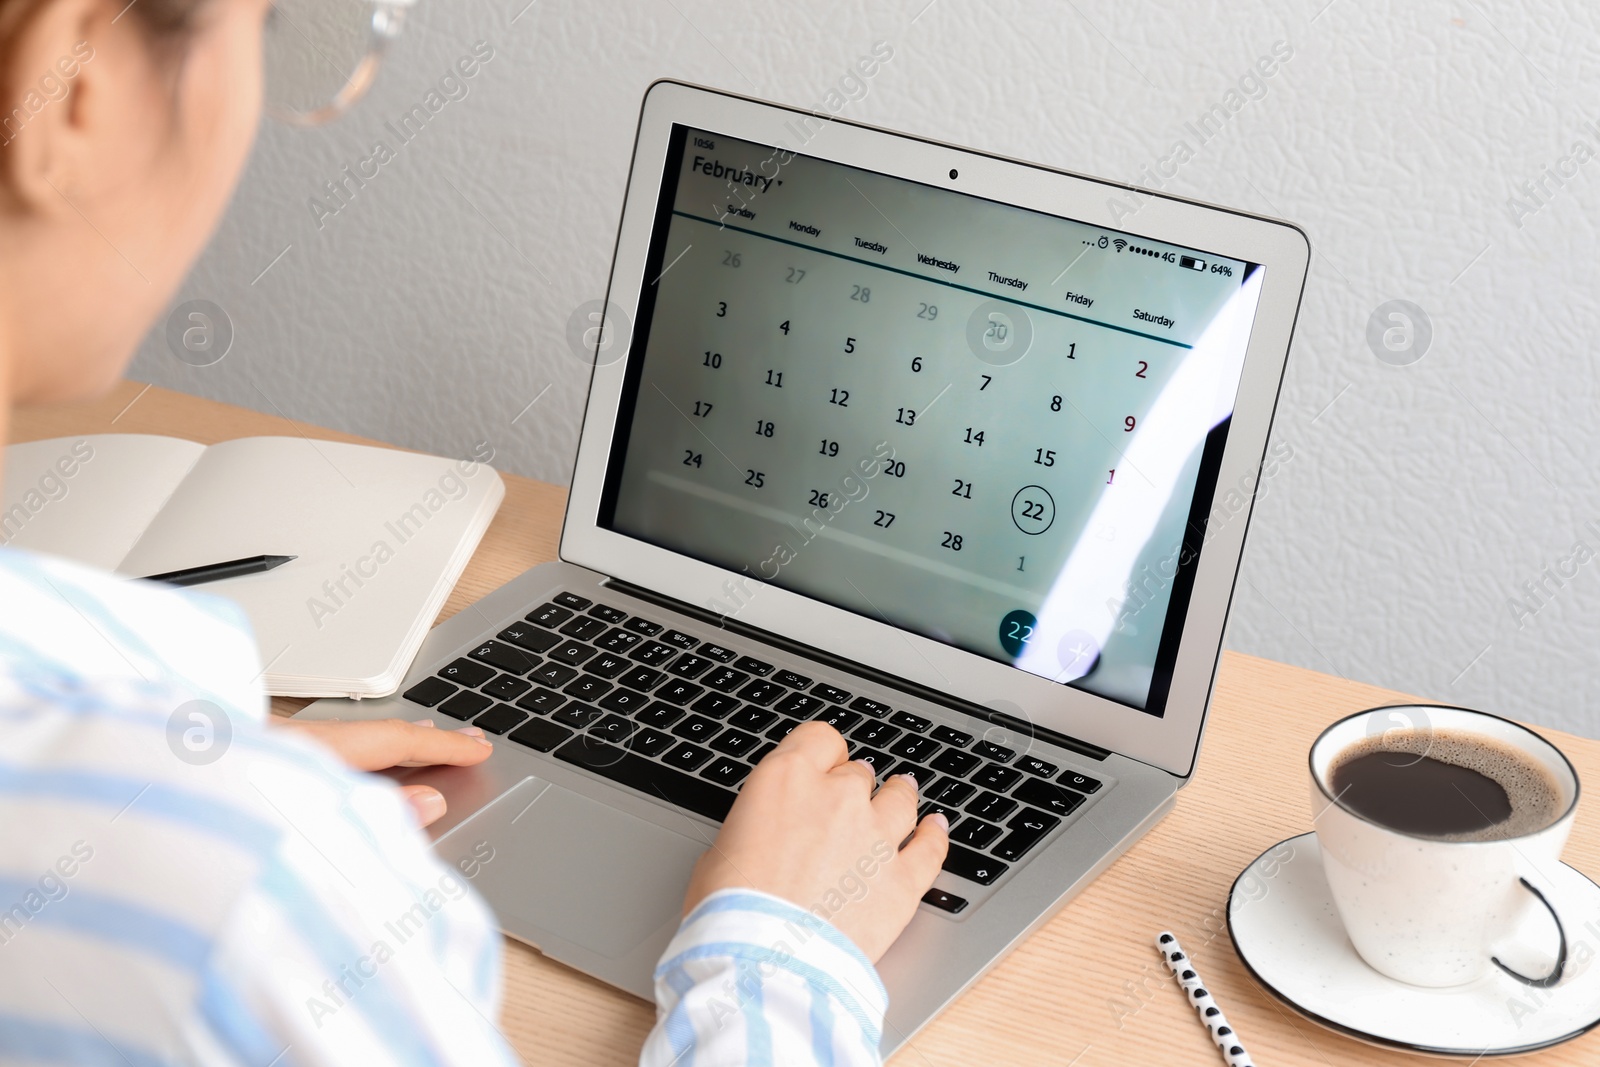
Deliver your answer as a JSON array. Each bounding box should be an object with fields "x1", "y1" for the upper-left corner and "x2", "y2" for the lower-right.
[{"x1": 1310, "y1": 704, "x2": 1578, "y2": 987}]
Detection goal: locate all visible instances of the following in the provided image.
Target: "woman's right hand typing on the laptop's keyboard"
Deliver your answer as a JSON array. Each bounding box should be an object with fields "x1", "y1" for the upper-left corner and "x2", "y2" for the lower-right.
[{"x1": 683, "y1": 721, "x2": 950, "y2": 961}]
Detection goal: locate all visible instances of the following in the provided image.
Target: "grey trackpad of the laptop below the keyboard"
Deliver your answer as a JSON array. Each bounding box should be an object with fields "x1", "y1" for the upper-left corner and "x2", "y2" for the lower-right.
[{"x1": 435, "y1": 776, "x2": 706, "y2": 960}]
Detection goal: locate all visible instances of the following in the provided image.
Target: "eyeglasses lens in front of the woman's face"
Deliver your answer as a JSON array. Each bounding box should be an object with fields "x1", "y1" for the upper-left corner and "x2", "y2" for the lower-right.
[{"x1": 262, "y1": 0, "x2": 416, "y2": 126}]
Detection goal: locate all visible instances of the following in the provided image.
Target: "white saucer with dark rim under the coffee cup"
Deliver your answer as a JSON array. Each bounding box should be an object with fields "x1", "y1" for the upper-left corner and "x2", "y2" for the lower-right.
[{"x1": 1227, "y1": 833, "x2": 1600, "y2": 1057}]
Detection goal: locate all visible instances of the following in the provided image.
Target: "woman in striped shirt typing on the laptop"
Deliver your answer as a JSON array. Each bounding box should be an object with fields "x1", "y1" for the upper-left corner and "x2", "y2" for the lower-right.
[{"x1": 0, "y1": 0, "x2": 947, "y2": 1067}]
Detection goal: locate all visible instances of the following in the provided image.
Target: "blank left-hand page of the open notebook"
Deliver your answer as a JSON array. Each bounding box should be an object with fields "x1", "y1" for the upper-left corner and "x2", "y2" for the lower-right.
[{"x1": 0, "y1": 434, "x2": 205, "y2": 571}]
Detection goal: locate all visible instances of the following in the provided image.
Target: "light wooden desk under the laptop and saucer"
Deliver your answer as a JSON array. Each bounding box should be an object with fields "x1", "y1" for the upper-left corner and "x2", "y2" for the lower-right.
[{"x1": 13, "y1": 382, "x2": 1600, "y2": 1067}]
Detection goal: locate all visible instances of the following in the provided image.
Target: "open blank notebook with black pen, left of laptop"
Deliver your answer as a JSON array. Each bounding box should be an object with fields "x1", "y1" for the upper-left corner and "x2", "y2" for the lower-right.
[{"x1": 0, "y1": 434, "x2": 506, "y2": 697}]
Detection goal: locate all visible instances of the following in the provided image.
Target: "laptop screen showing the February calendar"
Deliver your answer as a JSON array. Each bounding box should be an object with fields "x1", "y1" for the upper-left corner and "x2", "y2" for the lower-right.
[{"x1": 598, "y1": 126, "x2": 1262, "y2": 715}]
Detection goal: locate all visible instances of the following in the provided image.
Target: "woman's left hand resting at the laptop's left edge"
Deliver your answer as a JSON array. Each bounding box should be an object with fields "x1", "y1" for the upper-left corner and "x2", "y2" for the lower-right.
[{"x1": 278, "y1": 718, "x2": 494, "y2": 825}]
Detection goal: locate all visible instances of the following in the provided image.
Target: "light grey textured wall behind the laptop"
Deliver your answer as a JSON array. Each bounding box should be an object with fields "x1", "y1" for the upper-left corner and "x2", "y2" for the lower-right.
[{"x1": 133, "y1": 0, "x2": 1600, "y2": 736}]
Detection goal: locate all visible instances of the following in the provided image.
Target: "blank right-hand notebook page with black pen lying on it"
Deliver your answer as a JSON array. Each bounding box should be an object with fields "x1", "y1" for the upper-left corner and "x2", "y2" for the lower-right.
[{"x1": 123, "y1": 437, "x2": 504, "y2": 696}]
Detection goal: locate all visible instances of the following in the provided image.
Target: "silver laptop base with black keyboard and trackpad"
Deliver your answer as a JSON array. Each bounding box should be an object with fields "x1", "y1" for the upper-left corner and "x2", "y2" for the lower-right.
[{"x1": 298, "y1": 561, "x2": 1182, "y2": 1056}]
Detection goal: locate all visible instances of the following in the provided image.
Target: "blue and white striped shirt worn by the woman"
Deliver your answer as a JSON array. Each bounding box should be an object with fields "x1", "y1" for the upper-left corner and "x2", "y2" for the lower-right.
[{"x1": 0, "y1": 549, "x2": 886, "y2": 1067}]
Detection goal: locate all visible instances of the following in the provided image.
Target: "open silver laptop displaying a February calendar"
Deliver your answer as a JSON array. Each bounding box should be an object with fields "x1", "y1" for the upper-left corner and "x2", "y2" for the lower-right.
[{"x1": 301, "y1": 82, "x2": 1309, "y2": 1056}]
